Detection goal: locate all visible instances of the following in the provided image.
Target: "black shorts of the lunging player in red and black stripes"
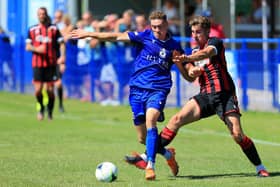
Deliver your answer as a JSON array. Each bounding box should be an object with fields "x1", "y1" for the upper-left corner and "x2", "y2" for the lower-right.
[{"x1": 193, "y1": 92, "x2": 241, "y2": 120}]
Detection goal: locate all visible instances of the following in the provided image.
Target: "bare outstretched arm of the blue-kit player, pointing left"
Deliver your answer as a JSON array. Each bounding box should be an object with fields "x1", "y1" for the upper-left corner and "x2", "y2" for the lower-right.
[{"x1": 70, "y1": 29, "x2": 130, "y2": 42}]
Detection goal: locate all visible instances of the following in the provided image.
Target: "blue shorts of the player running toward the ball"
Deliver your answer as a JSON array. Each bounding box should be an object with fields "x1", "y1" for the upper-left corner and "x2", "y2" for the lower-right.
[{"x1": 129, "y1": 87, "x2": 169, "y2": 125}]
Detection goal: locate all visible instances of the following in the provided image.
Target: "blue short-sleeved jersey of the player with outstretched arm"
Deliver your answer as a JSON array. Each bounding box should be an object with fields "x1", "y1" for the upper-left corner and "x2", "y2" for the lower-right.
[{"x1": 128, "y1": 30, "x2": 183, "y2": 91}]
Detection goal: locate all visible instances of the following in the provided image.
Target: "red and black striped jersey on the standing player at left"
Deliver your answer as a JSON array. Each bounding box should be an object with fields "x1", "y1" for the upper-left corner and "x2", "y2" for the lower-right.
[{"x1": 26, "y1": 24, "x2": 63, "y2": 68}]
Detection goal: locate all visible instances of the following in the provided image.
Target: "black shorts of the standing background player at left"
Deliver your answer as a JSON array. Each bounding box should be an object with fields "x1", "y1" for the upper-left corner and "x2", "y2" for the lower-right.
[{"x1": 33, "y1": 66, "x2": 58, "y2": 82}]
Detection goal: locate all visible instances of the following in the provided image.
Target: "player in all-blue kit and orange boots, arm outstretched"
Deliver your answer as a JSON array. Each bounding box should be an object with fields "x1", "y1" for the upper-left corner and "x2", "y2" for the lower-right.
[{"x1": 71, "y1": 11, "x2": 192, "y2": 180}]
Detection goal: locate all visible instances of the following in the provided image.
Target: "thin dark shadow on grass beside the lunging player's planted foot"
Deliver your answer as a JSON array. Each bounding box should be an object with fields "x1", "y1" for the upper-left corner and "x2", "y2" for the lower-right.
[{"x1": 176, "y1": 172, "x2": 280, "y2": 180}]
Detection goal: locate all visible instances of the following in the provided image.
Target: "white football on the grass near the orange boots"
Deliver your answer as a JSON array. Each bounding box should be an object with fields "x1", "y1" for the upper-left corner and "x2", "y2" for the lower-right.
[{"x1": 95, "y1": 162, "x2": 118, "y2": 182}]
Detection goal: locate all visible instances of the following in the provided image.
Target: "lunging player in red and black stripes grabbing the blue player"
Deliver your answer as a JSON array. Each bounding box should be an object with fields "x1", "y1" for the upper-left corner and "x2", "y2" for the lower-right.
[{"x1": 155, "y1": 16, "x2": 269, "y2": 177}]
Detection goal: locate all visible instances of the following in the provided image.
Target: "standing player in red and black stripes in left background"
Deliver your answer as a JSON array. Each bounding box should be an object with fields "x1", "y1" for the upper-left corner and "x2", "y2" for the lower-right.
[{"x1": 26, "y1": 7, "x2": 65, "y2": 120}]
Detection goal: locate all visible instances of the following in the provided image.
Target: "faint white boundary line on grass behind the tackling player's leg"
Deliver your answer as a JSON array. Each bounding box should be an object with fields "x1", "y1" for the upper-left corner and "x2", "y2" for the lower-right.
[{"x1": 179, "y1": 129, "x2": 280, "y2": 147}]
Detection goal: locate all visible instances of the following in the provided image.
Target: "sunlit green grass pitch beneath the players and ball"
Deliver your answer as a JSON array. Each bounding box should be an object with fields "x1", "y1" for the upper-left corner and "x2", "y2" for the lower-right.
[{"x1": 0, "y1": 92, "x2": 280, "y2": 187}]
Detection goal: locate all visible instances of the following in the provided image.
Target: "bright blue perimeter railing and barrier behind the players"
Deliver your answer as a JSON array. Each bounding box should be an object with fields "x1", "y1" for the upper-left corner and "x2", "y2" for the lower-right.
[{"x1": 0, "y1": 36, "x2": 280, "y2": 110}]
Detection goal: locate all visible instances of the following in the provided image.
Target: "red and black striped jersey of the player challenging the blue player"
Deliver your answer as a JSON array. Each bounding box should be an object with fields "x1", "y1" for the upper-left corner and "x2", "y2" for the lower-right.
[{"x1": 193, "y1": 37, "x2": 235, "y2": 93}]
